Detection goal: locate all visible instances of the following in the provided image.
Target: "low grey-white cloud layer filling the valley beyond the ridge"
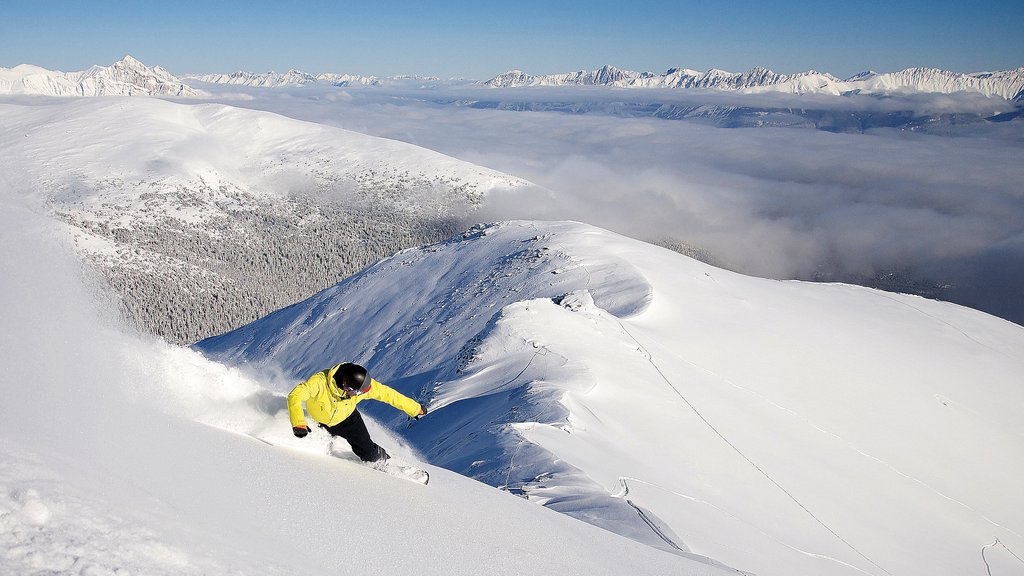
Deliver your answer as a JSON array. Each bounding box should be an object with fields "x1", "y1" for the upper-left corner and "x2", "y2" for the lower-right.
[{"x1": 197, "y1": 84, "x2": 1024, "y2": 323}]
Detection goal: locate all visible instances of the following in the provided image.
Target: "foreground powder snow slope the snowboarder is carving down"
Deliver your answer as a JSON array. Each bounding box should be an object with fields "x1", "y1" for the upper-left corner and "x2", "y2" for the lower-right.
[{"x1": 0, "y1": 190, "x2": 732, "y2": 576}]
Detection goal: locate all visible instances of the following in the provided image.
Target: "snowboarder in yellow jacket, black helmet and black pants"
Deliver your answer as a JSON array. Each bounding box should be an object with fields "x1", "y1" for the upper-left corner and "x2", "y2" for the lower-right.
[{"x1": 288, "y1": 362, "x2": 427, "y2": 463}]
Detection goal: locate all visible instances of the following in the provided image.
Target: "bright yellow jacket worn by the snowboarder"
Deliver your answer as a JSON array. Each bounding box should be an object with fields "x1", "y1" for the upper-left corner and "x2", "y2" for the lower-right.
[{"x1": 288, "y1": 364, "x2": 420, "y2": 426}]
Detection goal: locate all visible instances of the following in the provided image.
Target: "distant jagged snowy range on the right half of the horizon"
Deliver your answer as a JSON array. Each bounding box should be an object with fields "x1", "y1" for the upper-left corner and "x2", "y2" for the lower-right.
[{"x1": 482, "y1": 66, "x2": 1024, "y2": 99}]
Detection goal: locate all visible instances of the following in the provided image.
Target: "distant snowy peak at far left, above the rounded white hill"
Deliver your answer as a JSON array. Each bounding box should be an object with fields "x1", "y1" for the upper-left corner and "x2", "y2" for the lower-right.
[{"x1": 0, "y1": 55, "x2": 201, "y2": 96}]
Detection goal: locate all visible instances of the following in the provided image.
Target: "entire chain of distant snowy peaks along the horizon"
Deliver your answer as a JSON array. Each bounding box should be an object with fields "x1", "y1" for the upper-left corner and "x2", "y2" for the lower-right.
[{"x1": 0, "y1": 56, "x2": 1024, "y2": 100}]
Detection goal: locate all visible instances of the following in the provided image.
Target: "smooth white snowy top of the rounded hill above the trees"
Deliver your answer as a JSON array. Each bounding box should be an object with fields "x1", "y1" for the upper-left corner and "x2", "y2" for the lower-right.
[{"x1": 0, "y1": 98, "x2": 525, "y2": 202}]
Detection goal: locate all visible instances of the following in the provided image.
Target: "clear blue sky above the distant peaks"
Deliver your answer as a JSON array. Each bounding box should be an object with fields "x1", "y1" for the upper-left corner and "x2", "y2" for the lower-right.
[{"x1": 0, "y1": 0, "x2": 1024, "y2": 79}]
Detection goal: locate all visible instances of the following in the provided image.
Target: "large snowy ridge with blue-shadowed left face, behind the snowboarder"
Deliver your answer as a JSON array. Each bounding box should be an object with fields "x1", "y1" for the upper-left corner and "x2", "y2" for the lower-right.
[{"x1": 198, "y1": 221, "x2": 1024, "y2": 576}]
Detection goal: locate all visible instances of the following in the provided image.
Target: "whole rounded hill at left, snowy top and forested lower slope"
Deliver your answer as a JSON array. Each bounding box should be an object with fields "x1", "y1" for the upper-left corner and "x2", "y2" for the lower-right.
[{"x1": 0, "y1": 98, "x2": 531, "y2": 342}]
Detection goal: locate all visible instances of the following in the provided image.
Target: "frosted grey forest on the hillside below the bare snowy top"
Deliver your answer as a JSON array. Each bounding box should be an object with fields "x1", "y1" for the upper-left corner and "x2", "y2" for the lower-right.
[{"x1": 56, "y1": 177, "x2": 475, "y2": 343}]
